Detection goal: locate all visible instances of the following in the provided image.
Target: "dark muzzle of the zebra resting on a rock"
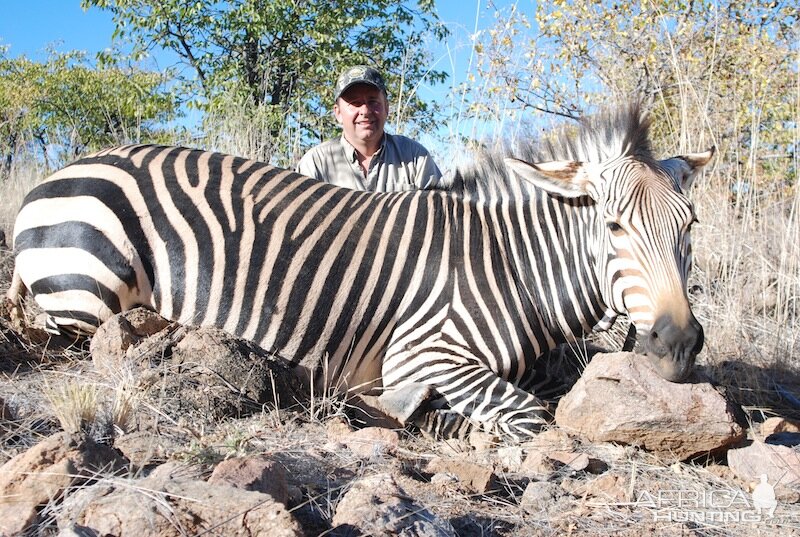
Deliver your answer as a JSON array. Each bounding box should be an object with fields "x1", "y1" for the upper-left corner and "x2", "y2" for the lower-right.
[{"x1": 639, "y1": 314, "x2": 705, "y2": 382}]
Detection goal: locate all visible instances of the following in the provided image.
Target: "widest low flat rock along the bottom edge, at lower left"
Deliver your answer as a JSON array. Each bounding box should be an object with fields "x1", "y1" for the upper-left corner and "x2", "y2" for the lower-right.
[{"x1": 58, "y1": 475, "x2": 303, "y2": 537}]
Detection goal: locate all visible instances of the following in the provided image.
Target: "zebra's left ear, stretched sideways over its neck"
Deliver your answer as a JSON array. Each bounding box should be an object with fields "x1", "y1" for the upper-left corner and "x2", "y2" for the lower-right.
[{"x1": 505, "y1": 158, "x2": 591, "y2": 198}]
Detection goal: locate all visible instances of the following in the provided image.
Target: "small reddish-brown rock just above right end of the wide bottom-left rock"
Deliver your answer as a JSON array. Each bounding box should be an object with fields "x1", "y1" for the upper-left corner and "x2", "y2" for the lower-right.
[{"x1": 208, "y1": 455, "x2": 289, "y2": 505}]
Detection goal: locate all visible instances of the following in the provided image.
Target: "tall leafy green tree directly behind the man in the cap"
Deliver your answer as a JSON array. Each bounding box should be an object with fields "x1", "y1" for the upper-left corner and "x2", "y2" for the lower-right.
[{"x1": 83, "y1": 0, "x2": 446, "y2": 163}]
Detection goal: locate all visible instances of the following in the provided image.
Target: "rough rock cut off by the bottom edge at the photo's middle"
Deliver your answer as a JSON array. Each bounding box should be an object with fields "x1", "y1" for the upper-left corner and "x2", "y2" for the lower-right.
[{"x1": 332, "y1": 473, "x2": 456, "y2": 537}]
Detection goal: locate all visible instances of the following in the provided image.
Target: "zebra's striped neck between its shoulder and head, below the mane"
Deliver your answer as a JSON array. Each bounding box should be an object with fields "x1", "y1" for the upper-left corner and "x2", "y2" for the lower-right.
[{"x1": 456, "y1": 188, "x2": 614, "y2": 350}]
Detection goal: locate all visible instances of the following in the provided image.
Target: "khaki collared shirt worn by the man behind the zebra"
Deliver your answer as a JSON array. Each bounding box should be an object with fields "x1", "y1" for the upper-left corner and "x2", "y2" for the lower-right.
[{"x1": 297, "y1": 133, "x2": 442, "y2": 192}]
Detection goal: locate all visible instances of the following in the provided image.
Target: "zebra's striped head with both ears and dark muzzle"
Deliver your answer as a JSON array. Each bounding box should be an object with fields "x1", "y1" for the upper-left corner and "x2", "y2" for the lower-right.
[{"x1": 506, "y1": 108, "x2": 714, "y2": 382}]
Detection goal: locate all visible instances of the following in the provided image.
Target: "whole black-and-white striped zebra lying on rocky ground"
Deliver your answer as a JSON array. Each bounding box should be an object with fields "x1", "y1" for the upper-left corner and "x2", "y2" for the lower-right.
[{"x1": 4, "y1": 102, "x2": 713, "y2": 435}]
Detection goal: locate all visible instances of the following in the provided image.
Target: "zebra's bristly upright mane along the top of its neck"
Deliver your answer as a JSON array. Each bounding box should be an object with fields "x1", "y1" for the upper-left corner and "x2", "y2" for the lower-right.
[{"x1": 450, "y1": 103, "x2": 654, "y2": 194}]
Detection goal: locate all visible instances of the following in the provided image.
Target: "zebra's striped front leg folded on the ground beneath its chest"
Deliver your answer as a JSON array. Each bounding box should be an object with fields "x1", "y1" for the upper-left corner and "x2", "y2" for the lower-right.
[{"x1": 383, "y1": 352, "x2": 552, "y2": 440}]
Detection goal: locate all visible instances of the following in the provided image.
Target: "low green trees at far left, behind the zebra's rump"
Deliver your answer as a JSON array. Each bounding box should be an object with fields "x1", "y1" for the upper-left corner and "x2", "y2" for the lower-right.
[{"x1": 0, "y1": 50, "x2": 177, "y2": 172}]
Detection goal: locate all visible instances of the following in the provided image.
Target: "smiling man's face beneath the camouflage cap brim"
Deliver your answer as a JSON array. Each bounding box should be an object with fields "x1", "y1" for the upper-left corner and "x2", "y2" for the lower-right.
[{"x1": 333, "y1": 84, "x2": 389, "y2": 149}]
